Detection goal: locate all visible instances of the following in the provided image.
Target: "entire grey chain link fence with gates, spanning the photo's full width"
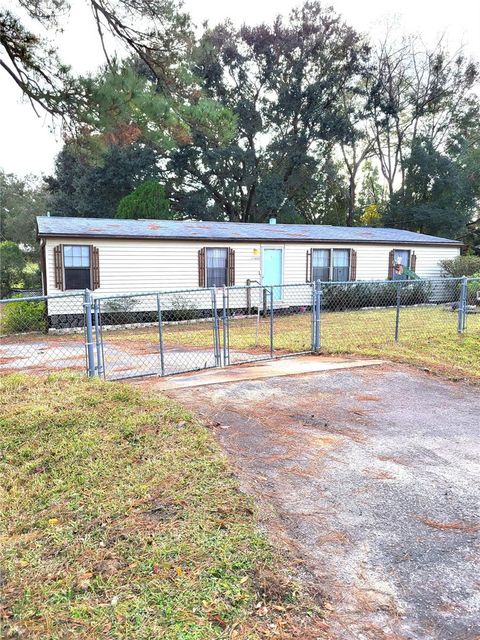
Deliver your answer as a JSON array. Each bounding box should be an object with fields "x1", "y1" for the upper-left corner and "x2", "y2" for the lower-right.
[{"x1": 0, "y1": 278, "x2": 480, "y2": 379}]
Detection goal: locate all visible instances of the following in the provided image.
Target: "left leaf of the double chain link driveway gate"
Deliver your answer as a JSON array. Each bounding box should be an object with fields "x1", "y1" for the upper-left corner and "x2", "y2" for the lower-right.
[{"x1": 93, "y1": 289, "x2": 220, "y2": 380}]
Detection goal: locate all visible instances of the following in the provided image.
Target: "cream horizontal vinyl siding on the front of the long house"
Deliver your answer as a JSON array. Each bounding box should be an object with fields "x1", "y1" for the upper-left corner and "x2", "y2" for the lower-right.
[{"x1": 45, "y1": 238, "x2": 460, "y2": 310}]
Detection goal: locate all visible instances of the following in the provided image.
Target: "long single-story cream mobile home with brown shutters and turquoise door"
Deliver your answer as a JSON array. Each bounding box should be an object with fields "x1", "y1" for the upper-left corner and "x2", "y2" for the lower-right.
[{"x1": 37, "y1": 216, "x2": 462, "y2": 324}]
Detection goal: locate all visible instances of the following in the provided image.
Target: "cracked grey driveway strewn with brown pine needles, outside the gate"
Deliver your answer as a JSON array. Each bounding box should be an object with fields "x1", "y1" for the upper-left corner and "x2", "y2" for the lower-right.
[{"x1": 156, "y1": 364, "x2": 480, "y2": 640}]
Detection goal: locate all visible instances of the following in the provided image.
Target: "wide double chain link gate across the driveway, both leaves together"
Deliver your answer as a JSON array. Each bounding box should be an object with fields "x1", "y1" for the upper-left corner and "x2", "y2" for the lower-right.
[{"x1": 86, "y1": 284, "x2": 314, "y2": 380}]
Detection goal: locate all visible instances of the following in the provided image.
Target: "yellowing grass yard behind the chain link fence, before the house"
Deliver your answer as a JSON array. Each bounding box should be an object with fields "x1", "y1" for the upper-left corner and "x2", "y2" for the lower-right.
[{"x1": 98, "y1": 306, "x2": 480, "y2": 380}]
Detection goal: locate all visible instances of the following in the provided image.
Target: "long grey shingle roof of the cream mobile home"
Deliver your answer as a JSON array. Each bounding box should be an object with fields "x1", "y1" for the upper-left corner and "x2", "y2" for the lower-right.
[{"x1": 37, "y1": 216, "x2": 461, "y2": 245}]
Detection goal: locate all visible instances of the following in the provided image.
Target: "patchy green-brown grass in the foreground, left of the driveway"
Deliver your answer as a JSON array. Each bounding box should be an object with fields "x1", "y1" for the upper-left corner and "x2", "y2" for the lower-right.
[{"x1": 0, "y1": 374, "x2": 325, "y2": 640}]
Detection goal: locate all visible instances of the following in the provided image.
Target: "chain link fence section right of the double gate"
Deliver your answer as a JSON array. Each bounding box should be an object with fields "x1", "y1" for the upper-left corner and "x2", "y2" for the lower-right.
[{"x1": 314, "y1": 278, "x2": 480, "y2": 377}]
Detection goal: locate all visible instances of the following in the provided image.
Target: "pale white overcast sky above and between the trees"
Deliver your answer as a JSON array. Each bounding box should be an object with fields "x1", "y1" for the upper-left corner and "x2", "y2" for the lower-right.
[{"x1": 0, "y1": 0, "x2": 480, "y2": 175}]
